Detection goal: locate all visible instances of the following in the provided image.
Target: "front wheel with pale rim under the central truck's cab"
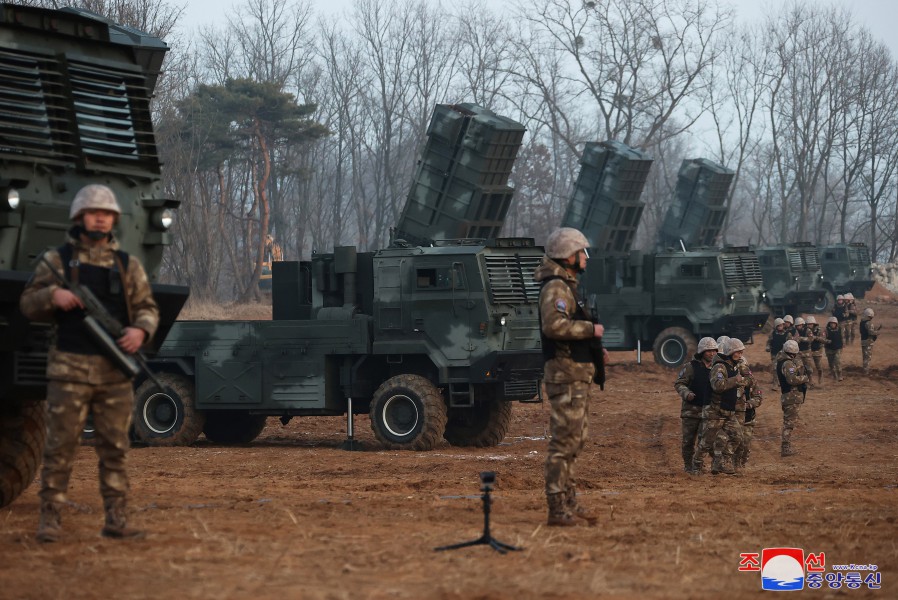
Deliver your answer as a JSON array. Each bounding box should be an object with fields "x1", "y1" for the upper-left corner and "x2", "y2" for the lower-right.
[{"x1": 371, "y1": 375, "x2": 446, "y2": 450}]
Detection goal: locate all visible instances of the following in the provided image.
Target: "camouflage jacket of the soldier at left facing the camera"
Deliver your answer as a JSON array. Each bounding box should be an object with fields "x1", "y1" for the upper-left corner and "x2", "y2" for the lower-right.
[{"x1": 19, "y1": 232, "x2": 159, "y2": 384}]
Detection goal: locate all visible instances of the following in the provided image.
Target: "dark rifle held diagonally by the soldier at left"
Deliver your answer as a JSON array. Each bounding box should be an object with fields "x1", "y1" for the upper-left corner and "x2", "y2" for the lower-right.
[{"x1": 41, "y1": 255, "x2": 165, "y2": 390}]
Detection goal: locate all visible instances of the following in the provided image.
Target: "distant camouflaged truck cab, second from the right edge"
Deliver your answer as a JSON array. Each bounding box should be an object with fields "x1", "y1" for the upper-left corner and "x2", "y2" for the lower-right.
[{"x1": 754, "y1": 242, "x2": 826, "y2": 316}]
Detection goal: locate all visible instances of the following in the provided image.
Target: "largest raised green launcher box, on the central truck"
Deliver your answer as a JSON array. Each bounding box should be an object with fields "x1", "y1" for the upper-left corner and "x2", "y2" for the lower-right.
[{"x1": 390, "y1": 103, "x2": 525, "y2": 246}]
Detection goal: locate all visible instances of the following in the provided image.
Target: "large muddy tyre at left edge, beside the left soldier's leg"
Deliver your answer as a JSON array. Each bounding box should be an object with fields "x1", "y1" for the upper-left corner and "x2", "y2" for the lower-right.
[{"x1": 0, "y1": 399, "x2": 47, "y2": 508}]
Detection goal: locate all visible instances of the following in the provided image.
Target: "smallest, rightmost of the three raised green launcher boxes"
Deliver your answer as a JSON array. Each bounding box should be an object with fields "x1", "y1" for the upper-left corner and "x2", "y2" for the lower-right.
[{"x1": 658, "y1": 158, "x2": 734, "y2": 251}]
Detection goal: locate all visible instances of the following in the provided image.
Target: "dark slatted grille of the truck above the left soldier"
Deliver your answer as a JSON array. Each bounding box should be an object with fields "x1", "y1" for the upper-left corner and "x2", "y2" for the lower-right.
[{"x1": 0, "y1": 49, "x2": 159, "y2": 172}]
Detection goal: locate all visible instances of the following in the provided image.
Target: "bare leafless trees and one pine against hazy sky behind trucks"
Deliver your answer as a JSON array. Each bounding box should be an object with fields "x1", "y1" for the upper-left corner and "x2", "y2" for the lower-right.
[{"x1": 22, "y1": 0, "x2": 898, "y2": 300}]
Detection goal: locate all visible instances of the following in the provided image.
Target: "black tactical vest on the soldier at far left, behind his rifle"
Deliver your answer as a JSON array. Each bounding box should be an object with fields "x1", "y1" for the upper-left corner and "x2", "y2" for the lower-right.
[{"x1": 55, "y1": 244, "x2": 130, "y2": 354}]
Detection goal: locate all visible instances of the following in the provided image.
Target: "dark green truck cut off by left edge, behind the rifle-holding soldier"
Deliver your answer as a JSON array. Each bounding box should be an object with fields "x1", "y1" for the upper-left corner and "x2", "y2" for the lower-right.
[{"x1": 0, "y1": 4, "x2": 187, "y2": 506}]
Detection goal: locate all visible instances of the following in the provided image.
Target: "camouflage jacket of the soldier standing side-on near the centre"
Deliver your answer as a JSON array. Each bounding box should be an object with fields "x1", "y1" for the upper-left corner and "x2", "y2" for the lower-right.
[{"x1": 533, "y1": 256, "x2": 595, "y2": 383}]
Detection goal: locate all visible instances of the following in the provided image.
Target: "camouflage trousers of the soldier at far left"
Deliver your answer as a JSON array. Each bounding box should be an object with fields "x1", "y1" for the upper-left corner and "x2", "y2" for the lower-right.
[{"x1": 39, "y1": 380, "x2": 133, "y2": 502}]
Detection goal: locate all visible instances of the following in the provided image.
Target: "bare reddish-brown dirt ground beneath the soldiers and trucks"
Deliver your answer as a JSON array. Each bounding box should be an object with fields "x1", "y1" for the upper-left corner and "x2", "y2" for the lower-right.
[{"x1": 0, "y1": 287, "x2": 898, "y2": 600}]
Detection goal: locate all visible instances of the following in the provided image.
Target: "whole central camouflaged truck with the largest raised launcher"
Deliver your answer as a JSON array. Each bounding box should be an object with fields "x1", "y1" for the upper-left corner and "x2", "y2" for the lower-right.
[{"x1": 135, "y1": 104, "x2": 543, "y2": 450}]
